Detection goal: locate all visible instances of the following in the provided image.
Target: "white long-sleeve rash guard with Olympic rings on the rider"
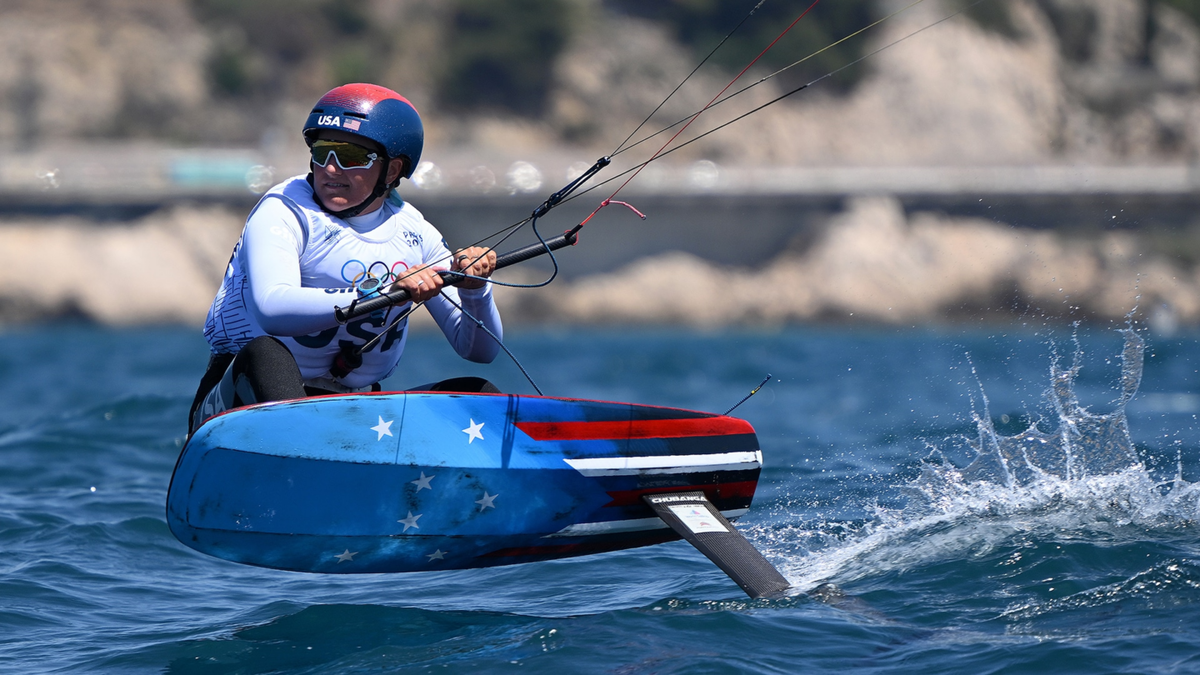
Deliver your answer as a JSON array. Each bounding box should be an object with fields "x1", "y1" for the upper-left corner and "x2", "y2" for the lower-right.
[{"x1": 205, "y1": 181, "x2": 503, "y2": 387}]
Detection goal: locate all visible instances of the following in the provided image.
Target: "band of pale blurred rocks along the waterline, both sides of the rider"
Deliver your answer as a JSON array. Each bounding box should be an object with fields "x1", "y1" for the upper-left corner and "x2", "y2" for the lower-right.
[{"x1": 0, "y1": 197, "x2": 1200, "y2": 327}]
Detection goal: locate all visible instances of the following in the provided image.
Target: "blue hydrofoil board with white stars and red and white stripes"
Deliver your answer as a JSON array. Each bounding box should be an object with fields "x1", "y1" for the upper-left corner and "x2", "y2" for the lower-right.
[{"x1": 167, "y1": 392, "x2": 787, "y2": 595}]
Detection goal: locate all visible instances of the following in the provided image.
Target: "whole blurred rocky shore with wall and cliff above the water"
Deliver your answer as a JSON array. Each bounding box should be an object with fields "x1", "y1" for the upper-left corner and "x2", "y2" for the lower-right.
[{"x1": 0, "y1": 0, "x2": 1200, "y2": 331}]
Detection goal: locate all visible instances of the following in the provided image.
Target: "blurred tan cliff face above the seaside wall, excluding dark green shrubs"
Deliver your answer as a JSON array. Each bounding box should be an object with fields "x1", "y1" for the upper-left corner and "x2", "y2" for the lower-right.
[{"x1": 0, "y1": 0, "x2": 1200, "y2": 165}]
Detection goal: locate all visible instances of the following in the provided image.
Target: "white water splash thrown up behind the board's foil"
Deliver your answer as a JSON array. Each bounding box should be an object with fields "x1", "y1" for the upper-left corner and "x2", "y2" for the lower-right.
[{"x1": 758, "y1": 329, "x2": 1200, "y2": 591}]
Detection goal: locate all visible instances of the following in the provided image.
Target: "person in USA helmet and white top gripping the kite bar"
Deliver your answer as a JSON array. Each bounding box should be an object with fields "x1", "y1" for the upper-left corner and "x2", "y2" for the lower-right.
[{"x1": 188, "y1": 84, "x2": 502, "y2": 432}]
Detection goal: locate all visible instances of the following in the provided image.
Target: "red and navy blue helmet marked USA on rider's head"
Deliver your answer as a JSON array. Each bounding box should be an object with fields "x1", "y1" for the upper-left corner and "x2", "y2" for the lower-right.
[{"x1": 304, "y1": 84, "x2": 425, "y2": 178}]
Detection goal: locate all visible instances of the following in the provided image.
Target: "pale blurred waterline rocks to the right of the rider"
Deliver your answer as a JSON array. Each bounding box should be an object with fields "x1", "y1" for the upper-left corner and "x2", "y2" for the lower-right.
[{"x1": 512, "y1": 197, "x2": 1200, "y2": 327}]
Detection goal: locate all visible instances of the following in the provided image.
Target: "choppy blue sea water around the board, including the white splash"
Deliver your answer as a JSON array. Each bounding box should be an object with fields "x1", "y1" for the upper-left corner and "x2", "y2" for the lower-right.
[{"x1": 0, "y1": 324, "x2": 1200, "y2": 674}]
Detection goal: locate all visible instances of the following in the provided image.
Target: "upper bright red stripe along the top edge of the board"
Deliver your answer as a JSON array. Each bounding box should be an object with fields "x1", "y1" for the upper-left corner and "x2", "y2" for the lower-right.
[{"x1": 516, "y1": 417, "x2": 754, "y2": 441}]
